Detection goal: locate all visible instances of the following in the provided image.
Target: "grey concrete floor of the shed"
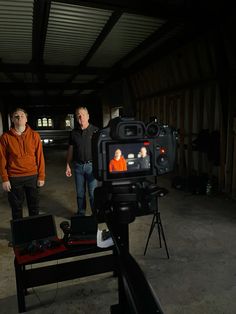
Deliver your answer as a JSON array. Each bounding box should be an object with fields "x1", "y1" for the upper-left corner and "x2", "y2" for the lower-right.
[{"x1": 0, "y1": 148, "x2": 236, "y2": 314}]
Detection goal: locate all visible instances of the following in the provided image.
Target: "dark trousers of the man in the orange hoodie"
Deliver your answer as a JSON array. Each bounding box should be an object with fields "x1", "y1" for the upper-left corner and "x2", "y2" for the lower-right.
[{"x1": 8, "y1": 175, "x2": 39, "y2": 219}]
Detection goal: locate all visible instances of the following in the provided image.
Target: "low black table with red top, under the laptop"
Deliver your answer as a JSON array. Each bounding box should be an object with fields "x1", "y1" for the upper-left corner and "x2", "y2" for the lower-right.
[{"x1": 14, "y1": 243, "x2": 117, "y2": 313}]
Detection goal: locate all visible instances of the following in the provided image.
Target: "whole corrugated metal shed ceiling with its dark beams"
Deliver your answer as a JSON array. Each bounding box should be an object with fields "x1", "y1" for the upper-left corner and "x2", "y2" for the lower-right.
[{"x1": 0, "y1": 0, "x2": 227, "y2": 104}]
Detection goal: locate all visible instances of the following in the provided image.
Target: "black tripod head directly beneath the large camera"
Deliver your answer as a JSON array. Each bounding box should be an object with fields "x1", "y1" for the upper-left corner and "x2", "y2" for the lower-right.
[{"x1": 94, "y1": 180, "x2": 168, "y2": 224}]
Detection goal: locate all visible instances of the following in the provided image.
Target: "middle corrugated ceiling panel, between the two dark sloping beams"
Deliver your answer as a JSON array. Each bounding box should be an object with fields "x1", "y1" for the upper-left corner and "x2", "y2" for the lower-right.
[{"x1": 44, "y1": 3, "x2": 112, "y2": 65}]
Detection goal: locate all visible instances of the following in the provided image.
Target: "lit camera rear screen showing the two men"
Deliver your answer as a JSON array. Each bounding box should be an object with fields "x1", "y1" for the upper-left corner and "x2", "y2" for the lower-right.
[{"x1": 106, "y1": 140, "x2": 153, "y2": 180}]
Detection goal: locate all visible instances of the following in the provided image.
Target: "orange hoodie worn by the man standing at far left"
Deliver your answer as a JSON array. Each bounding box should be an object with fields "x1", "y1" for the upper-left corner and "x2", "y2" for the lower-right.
[{"x1": 0, "y1": 125, "x2": 45, "y2": 182}]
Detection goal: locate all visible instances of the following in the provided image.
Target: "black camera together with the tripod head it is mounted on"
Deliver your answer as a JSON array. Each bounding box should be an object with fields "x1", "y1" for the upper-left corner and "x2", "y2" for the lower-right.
[{"x1": 92, "y1": 117, "x2": 176, "y2": 223}]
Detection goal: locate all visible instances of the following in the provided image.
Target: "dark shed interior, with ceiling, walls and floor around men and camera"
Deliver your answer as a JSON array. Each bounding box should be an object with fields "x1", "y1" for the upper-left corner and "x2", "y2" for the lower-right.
[{"x1": 0, "y1": 0, "x2": 236, "y2": 314}]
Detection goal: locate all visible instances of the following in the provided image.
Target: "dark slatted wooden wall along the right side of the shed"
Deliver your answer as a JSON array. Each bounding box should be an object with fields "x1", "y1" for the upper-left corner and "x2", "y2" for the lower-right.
[{"x1": 127, "y1": 25, "x2": 236, "y2": 193}]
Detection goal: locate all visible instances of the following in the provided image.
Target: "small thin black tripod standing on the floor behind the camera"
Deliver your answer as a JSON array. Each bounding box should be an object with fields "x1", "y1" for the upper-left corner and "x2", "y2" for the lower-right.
[{"x1": 144, "y1": 187, "x2": 170, "y2": 259}]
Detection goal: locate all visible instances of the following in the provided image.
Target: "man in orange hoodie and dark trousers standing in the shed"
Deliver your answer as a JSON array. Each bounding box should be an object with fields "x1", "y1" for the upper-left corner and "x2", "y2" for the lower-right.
[{"x1": 0, "y1": 108, "x2": 45, "y2": 219}]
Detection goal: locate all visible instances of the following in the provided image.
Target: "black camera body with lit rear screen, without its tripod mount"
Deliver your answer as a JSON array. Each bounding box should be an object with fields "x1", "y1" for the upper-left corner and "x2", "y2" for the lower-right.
[{"x1": 92, "y1": 117, "x2": 176, "y2": 183}]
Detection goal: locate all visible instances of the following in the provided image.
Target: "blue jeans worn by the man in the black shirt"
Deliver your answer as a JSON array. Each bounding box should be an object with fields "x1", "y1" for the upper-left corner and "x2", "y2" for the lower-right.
[{"x1": 74, "y1": 163, "x2": 97, "y2": 216}]
